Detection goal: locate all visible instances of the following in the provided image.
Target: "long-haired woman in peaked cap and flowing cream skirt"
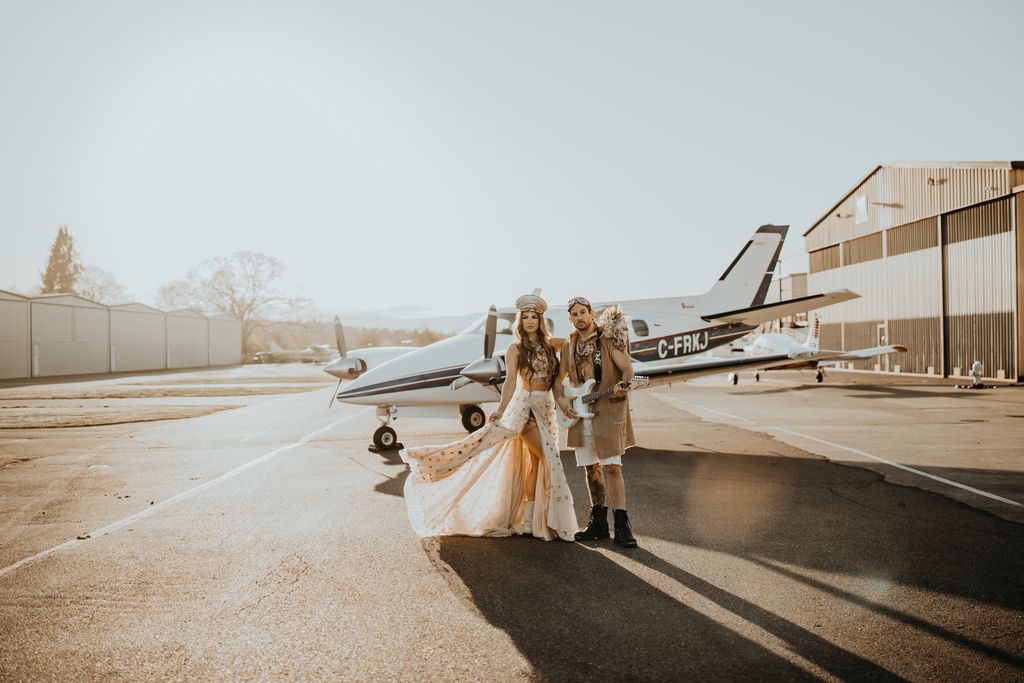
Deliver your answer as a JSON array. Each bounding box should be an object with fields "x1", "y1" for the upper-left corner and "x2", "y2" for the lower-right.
[{"x1": 400, "y1": 294, "x2": 579, "y2": 541}]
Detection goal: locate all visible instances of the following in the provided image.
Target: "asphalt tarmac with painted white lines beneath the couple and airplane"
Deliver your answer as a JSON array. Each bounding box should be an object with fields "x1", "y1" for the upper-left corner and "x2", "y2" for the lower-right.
[{"x1": 0, "y1": 369, "x2": 1024, "y2": 681}]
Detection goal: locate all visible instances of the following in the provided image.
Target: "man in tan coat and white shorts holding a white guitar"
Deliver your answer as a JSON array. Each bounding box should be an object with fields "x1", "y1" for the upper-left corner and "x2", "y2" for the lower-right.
[{"x1": 554, "y1": 297, "x2": 637, "y2": 548}]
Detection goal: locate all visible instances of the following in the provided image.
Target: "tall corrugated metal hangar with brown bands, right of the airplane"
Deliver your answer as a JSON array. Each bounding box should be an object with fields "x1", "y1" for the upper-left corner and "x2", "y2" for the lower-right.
[{"x1": 804, "y1": 161, "x2": 1024, "y2": 380}]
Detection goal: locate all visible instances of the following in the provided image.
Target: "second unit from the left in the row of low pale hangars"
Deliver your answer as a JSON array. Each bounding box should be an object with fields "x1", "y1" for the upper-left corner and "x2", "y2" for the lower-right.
[{"x1": 31, "y1": 294, "x2": 111, "y2": 377}]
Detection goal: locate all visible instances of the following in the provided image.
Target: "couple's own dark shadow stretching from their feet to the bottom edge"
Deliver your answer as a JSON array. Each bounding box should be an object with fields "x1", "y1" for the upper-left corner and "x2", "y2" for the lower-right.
[{"x1": 424, "y1": 537, "x2": 891, "y2": 680}]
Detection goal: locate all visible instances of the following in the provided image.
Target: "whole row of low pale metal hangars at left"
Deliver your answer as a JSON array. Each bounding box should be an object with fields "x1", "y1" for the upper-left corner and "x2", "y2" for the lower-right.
[{"x1": 0, "y1": 290, "x2": 242, "y2": 380}]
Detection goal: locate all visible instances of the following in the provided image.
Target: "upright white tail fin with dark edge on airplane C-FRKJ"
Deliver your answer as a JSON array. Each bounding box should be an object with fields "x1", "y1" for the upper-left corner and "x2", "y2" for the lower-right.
[{"x1": 700, "y1": 225, "x2": 790, "y2": 310}]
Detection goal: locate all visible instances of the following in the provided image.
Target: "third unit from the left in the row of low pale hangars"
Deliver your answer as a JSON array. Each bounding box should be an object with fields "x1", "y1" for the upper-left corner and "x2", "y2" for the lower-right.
[{"x1": 110, "y1": 303, "x2": 167, "y2": 373}]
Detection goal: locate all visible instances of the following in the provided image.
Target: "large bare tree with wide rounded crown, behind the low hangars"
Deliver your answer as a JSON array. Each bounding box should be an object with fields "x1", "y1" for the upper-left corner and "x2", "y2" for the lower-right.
[{"x1": 159, "y1": 251, "x2": 307, "y2": 353}]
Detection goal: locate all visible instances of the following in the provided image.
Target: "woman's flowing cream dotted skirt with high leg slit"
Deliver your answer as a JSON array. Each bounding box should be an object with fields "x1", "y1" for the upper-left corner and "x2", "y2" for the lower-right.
[{"x1": 400, "y1": 388, "x2": 580, "y2": 541}]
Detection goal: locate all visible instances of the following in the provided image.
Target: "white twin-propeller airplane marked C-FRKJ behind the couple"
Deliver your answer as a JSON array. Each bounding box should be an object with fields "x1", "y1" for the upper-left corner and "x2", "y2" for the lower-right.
[{"x1": 337, "y1": 225, "x2": 859, "y2": 451}]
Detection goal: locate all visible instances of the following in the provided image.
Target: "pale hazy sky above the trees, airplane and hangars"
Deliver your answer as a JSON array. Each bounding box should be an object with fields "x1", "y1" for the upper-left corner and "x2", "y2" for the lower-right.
[{"x1": 0, "y1": 0, "x2": 1024, "y2": 312}]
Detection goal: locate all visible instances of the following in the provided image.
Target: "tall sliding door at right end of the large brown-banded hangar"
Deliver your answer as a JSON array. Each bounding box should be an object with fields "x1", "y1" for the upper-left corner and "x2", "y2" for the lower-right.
[{"x1": 942, "y1": 198, "x2": 1017, "y2": 379}]
